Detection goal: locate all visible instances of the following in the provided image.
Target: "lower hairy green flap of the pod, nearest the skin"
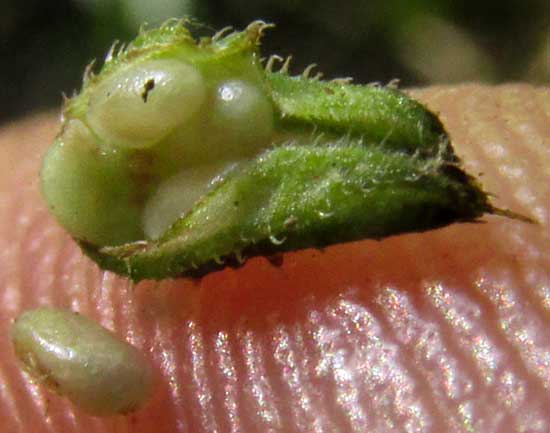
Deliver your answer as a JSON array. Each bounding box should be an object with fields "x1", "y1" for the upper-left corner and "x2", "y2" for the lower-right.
[{"x1": 87, "y1": 143, "x2": 491, "y2": 280}]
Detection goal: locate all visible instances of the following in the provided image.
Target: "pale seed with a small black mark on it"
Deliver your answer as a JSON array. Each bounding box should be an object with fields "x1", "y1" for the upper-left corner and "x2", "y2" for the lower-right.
[{"x1": 86, "y1": 59, "x2": 205, "y2": 149}]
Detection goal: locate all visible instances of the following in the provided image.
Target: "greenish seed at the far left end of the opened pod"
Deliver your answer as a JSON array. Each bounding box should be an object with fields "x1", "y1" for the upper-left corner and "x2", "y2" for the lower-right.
[{"x1": 41, "y1": 119, "x2": 145, "y2": 245}]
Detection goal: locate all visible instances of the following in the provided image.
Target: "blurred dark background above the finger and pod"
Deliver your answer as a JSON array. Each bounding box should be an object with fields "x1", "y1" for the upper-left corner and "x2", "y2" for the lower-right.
[{"x1": 0, "y1": 0, "x2": 550, "y2": 123}]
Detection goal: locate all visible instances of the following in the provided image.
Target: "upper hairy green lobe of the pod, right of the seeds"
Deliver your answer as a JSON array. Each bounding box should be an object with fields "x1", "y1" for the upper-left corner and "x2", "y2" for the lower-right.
[{"x1": 266, "y1": 72, "x2": 456, "y2": 161}]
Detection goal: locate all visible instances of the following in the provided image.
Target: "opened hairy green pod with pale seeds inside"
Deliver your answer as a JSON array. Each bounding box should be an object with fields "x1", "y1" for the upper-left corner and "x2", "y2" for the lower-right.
[{"x1": 42, "y1": 21, "x2": 524, "y2": 280}]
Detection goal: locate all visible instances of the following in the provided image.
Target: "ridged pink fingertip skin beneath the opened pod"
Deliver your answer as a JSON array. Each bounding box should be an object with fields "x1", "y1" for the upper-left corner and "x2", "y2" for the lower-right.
[{"x1": 0, "y1": 85, "x2": 550, "y2": 433}]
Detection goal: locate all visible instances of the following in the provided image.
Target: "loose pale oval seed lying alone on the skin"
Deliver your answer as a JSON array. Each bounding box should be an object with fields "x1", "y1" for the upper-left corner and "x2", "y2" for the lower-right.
[{"x1": 11, "y1": 308, "x2": 153, "y2": 415}]
